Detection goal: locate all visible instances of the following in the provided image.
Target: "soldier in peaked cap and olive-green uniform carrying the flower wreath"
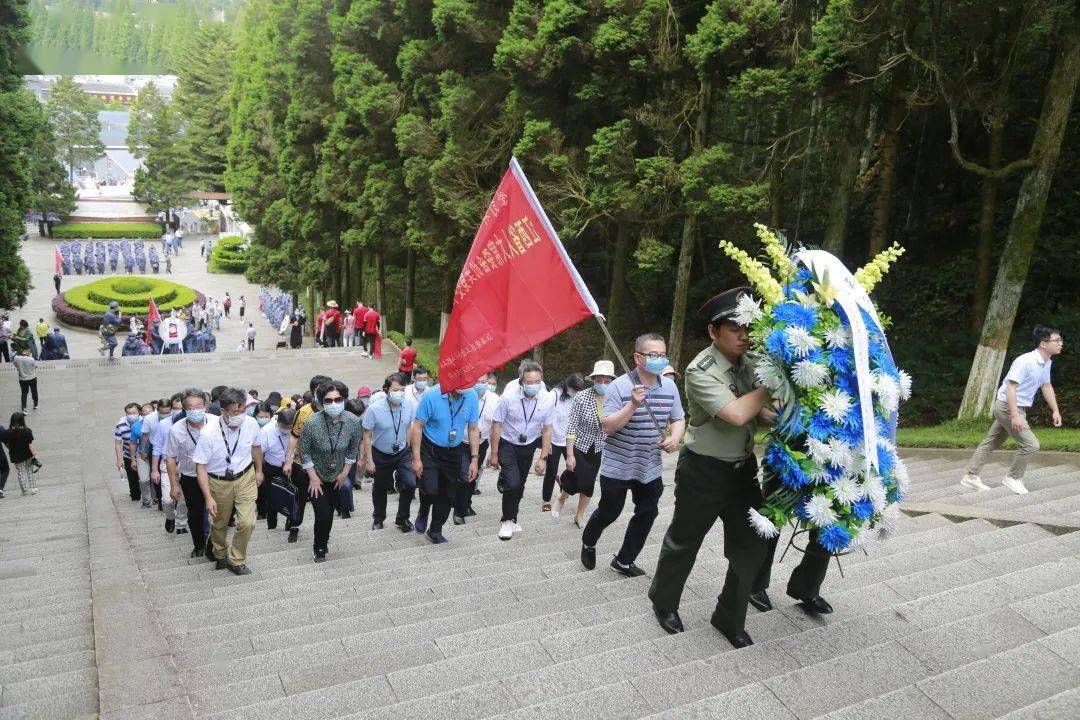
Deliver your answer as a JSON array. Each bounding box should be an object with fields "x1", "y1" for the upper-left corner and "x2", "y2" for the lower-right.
[{"x1": 649, "y1": 287, "x2": 772, "y2": 648}]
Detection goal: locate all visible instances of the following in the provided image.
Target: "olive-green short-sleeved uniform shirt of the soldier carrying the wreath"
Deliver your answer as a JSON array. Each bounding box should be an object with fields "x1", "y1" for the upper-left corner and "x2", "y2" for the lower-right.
[{"x1": 686, "y1": 344, "x2": 757, "y2": 462}]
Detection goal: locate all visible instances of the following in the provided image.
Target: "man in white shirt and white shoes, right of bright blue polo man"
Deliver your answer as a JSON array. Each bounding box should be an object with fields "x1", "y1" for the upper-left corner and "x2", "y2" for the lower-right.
[{"x1": 487, "y1": 361, "x2": 555, "y2": 540}]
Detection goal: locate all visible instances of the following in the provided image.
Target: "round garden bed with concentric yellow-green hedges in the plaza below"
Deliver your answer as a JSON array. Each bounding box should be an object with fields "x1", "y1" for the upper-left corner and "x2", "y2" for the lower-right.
[{"x1": 53, "y1": 275, "x2": 206, "y2": 330}]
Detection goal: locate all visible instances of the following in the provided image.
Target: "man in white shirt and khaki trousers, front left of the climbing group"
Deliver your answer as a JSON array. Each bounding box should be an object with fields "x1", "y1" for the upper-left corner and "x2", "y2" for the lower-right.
[{"x1": 192, "y1": 388, "x2": 262, "y2": 575}]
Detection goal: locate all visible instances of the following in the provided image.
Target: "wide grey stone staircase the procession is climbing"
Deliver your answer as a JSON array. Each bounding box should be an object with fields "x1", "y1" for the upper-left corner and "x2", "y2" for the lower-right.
[{"x1": 0, "y1": 355, "x2": 1080, "y2": 720}]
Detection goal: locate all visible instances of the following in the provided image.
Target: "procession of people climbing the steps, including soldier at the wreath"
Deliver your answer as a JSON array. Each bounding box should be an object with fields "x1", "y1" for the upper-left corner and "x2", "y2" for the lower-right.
[{"x1": 116, "y1": 288, "x2": 832, "y2": 648}]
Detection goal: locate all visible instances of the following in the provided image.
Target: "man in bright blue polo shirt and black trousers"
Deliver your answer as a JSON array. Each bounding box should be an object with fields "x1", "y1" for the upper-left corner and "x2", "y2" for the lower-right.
[{"x1": 409, "y1": 384, "x2": 480, "y2": 544}]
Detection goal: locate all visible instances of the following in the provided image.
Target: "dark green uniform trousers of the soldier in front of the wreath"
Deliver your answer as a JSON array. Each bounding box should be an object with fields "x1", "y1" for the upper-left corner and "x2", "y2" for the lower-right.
[{"x1": 649, "y1": 448, "x2": 766, "y2": 635}]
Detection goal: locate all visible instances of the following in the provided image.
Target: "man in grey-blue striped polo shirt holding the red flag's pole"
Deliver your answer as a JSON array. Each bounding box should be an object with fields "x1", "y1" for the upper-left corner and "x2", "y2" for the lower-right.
[{"x1": 581, "y1": 332, "x2": 686, "y2": 578}]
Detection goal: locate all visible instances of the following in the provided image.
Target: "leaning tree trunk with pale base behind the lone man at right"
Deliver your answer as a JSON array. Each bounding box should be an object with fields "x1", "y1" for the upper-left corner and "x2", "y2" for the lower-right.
[{"x1": 958, "y1": 11, "x2": 1080, "y2": 418}]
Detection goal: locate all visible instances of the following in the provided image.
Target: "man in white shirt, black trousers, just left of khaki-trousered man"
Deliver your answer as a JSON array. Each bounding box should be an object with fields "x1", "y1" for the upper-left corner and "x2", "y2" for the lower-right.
[{"x1": 162, "y1": 388, "x2": 218, "y2": 557}]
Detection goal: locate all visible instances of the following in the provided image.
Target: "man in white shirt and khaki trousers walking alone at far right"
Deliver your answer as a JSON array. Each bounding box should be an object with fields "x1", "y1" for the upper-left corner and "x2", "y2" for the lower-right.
[{"x1": 960, "y1": 325, "x2": 1065, "y2": 495}]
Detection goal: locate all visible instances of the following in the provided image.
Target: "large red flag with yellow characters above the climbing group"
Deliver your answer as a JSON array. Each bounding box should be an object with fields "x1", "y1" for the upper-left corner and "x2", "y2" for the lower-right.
[{"x1": 438, "y1": 159, "x2": 599, "y2": 392}]
